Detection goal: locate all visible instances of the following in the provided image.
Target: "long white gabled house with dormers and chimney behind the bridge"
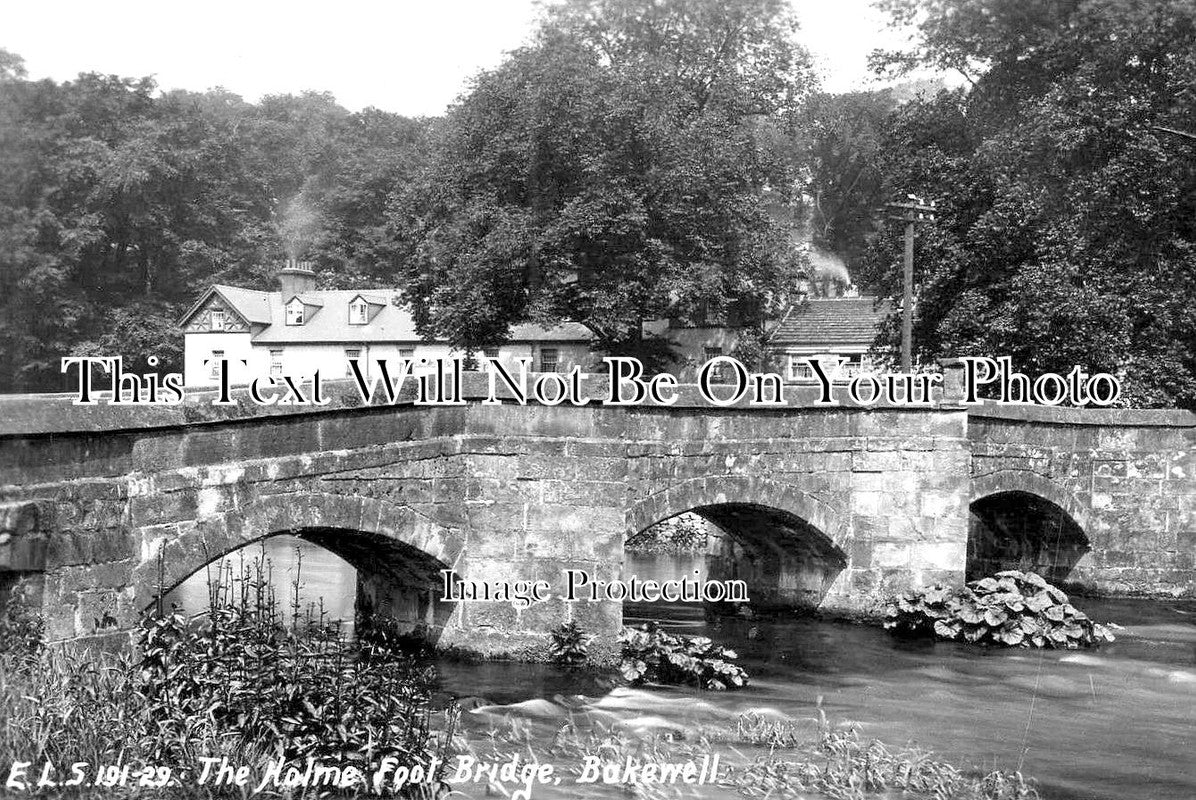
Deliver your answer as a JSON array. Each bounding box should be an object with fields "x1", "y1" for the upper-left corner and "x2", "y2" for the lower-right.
[{"x1": 179, "y1": 262, "x2": 594, "y2": 386}]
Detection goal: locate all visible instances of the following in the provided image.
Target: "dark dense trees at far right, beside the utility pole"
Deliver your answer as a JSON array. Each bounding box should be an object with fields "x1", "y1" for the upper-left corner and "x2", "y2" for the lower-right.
[{"x1": 867, "y1": 0, "x2": 1196, "y2": 407}]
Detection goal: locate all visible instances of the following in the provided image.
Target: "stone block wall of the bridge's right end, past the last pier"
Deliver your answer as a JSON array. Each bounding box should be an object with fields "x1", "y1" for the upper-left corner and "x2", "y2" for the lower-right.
[{"x1": 969, "y1": 409, "x2": 1196, "y2": 597}]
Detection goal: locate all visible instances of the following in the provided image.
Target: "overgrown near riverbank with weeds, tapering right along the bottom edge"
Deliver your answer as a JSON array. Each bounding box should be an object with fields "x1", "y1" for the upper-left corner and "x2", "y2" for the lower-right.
[{"x1": 0, "y1": 581, "x2": 1038, "y2": 800}]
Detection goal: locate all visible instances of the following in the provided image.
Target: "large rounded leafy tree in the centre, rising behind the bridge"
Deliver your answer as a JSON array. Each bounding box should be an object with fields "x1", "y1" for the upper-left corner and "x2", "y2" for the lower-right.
[{"x1": 392, "y1": 0, "x2": 808, "y2": 349}]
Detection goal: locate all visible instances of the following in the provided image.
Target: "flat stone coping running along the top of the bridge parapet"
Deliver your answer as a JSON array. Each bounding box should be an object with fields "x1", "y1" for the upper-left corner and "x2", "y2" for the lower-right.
[{"x1": 0, "y1": 373, "x2": 1196, "y2": 436}]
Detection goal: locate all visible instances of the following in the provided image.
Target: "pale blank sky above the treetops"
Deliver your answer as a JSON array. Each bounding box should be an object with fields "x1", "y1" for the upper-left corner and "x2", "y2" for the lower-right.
[{"x1": 0, "y1": 0, "x2": 918, "y2": 116}]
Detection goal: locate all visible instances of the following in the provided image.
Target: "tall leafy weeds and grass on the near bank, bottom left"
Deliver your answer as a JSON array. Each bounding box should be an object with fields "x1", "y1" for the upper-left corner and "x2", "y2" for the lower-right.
[{"x1": 0, "y1": 554, "x2": 456, "y2": 798}]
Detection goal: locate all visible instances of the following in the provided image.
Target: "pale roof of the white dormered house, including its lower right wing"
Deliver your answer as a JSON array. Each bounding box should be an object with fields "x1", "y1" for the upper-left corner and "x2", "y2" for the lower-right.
[{"x1": 179, "y1": 285, "x2": 592, "y2": 344}]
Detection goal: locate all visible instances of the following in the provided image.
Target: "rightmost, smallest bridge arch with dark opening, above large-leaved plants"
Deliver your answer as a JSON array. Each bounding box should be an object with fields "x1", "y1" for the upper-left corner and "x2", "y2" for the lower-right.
[{"x1": 965, "y1": 470, "x2": 1091, "y2": 584}]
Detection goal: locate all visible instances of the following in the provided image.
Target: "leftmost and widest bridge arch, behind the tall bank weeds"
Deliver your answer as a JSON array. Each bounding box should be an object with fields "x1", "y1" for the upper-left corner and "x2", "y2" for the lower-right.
[{"x1": 133, "y1": 493, "x2": 464, "y2": 627}]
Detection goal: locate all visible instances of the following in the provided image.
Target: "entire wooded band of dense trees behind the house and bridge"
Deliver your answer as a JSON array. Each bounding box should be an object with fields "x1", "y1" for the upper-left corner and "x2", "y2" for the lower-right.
[{"x1": 0, "y1": 0, "x2": 1196, "y2": 407}]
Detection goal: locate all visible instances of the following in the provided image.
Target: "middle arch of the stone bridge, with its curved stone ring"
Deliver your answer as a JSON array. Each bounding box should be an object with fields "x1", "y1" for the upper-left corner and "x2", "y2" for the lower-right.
[{"x1": 624, "y1": 476, "x2": 849, "y2": 609}]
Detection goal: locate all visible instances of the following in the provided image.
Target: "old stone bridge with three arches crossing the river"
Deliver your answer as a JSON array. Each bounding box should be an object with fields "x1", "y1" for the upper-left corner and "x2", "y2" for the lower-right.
[{"x1": 0, "y1": 377, "x2": 1196, "y2": 653}]
